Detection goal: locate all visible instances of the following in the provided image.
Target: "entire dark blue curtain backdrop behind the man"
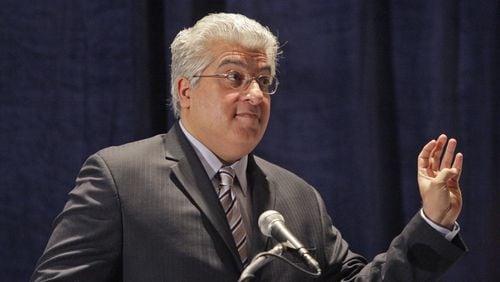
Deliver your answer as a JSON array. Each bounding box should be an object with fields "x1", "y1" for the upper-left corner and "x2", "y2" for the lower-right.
[{"x1": 0, "y1": 0, "x2": 500, "y2": 281}]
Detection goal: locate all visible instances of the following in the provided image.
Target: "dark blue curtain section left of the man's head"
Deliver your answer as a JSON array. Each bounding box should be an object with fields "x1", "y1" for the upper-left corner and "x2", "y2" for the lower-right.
[{"x1": 0, "y1": 0, "x2": 158, "y2": 281}]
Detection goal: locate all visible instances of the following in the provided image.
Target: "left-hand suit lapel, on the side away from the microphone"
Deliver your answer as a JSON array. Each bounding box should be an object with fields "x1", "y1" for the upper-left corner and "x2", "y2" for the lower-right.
[{"x1": 165, "y1": 124, "x2": 242, "y2": 269}]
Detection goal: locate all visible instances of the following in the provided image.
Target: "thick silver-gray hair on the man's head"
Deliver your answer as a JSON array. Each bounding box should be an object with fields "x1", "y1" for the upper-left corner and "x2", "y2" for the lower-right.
[{"x1": 170, "y1": 13, "x2": 279, "y2": 118}]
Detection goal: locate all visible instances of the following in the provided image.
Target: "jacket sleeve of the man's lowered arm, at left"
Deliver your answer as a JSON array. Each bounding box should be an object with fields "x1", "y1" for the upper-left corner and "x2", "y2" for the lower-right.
[{"x1": 30, "y1": 154, "x2": 122, "y2": 281}]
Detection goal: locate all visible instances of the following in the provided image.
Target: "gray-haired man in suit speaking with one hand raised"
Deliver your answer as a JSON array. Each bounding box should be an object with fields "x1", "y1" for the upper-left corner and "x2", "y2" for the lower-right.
[{"x1": 32, "y1": 14, "x2": 466, "y2": 282}]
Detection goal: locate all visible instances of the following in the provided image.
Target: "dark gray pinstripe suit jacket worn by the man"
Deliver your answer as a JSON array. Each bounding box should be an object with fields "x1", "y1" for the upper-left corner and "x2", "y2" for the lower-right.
[{"x1": 31, "y1": 125, "x2": 466, "y2": 282}]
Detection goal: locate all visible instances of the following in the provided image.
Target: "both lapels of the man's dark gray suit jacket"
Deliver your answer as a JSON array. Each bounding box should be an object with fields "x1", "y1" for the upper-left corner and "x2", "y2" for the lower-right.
[{"x1": 164, "y1": 124, "x2": 276, "y2": 270}]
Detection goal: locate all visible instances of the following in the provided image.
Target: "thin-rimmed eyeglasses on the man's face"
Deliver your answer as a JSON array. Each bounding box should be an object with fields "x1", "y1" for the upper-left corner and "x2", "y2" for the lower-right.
[{"x1": 193, "y1": 70, "x2": 279, "y2": 95}]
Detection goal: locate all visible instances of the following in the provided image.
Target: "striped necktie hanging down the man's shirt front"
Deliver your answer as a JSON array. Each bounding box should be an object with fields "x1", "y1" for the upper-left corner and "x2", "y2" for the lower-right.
[{"x1": 219, "y1": 166, "x2": 248, "y2": 266}]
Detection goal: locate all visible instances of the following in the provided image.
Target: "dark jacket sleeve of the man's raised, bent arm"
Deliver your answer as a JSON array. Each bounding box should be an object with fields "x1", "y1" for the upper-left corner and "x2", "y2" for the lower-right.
[{"x1": 318, "y1": 189, "x2": 467, "y2": 281}]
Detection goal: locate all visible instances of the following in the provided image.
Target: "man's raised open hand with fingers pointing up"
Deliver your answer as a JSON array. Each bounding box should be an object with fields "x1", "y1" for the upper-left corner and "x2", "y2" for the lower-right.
[{"x1": 417, "y1": 134, "x2": 463, "y2": 230}]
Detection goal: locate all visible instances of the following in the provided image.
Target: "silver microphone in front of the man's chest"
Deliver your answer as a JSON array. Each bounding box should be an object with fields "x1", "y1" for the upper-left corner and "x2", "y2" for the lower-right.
[{"x1": 258, "y1": 210, "x2": 321, "y2": 273}]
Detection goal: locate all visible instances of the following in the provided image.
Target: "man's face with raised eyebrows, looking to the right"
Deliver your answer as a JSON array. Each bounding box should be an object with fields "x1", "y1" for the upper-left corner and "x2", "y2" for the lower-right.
[{"x1": 177, "y1": 40, "x2": 271, "y2": 163}]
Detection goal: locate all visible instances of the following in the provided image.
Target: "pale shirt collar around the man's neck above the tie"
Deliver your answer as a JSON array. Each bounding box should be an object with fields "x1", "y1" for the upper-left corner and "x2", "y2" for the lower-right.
[{"x1": 179, "y1": 120, "x2": 248, "y2": 195}]
